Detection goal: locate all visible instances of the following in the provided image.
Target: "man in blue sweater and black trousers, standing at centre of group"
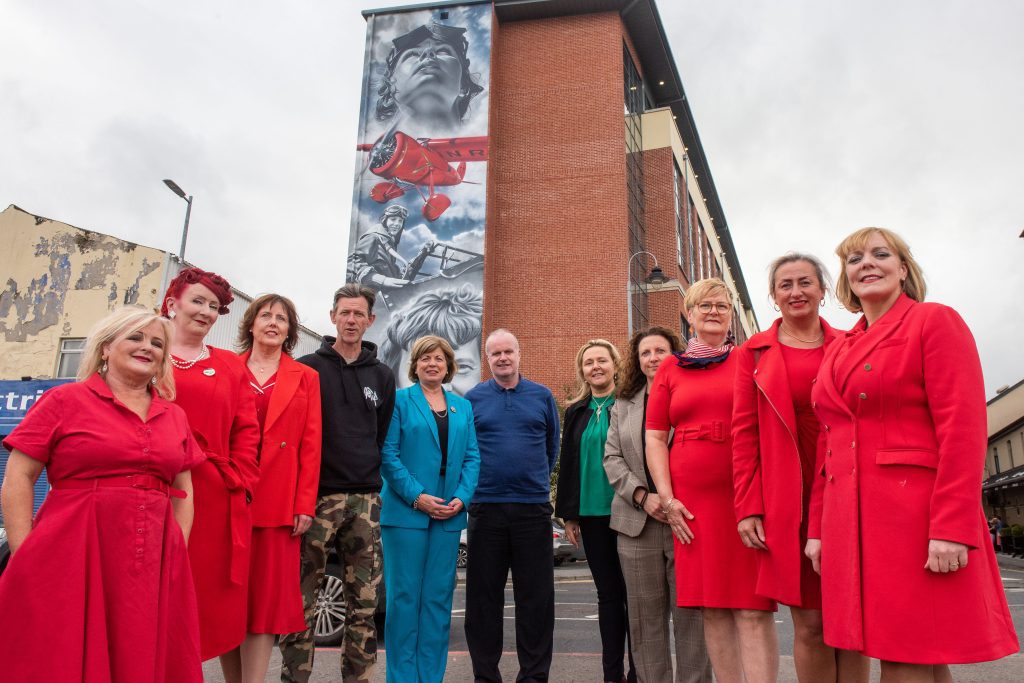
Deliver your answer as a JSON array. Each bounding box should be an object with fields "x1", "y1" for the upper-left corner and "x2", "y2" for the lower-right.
[{"x1": 466, "y1": 330, "x2": 559, "y2": 683}]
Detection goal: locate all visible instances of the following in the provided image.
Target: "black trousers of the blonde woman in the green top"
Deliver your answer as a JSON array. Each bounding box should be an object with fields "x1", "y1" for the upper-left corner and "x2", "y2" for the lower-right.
[{"x1": 580, "y1": 516, "x2": 636, "y2": 683}]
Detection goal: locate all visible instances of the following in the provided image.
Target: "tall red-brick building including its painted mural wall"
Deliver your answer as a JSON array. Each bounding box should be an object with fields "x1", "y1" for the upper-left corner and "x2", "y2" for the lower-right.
[{"x1": 349, "y1": 0, "x2": 757, "y2": 399}]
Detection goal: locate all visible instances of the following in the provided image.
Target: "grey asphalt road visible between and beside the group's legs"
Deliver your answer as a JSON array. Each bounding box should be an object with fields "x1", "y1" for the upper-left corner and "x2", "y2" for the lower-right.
[{"x1": 204, "y1": 564, "x2": 1024, "y2": 683}]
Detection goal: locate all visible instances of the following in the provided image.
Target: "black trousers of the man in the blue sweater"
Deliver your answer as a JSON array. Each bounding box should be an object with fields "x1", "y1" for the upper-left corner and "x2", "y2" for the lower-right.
[{"x1": 466, "y1": 503, "x2": 555, "y2": 683}]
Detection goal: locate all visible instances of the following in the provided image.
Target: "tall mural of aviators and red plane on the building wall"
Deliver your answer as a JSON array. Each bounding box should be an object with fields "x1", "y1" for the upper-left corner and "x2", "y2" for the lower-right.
[{"x1": 347, "y1": 3, "x2": 490, "y2": 393}]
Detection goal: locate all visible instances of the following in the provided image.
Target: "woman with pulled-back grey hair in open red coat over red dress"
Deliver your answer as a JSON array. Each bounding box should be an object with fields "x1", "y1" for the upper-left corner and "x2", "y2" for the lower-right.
[{"x1": 732, "y1": 253, "x2": 868, "y2": 682}]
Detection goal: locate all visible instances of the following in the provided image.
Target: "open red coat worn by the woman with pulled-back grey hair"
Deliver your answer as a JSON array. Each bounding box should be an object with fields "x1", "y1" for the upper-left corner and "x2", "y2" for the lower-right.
[{"x1": 732, "y1": 318, "x2": 841, "y2": 605}]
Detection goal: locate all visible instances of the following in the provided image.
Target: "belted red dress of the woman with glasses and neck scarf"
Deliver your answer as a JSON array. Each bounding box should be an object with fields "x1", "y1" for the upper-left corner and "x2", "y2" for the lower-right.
[{"x1": 647, "y1": 353, "x2": 776, "y2": 610}]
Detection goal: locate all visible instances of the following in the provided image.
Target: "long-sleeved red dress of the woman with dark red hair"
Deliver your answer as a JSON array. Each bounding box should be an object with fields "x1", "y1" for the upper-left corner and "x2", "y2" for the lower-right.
[{"x1": 174, "y1": 346, "x2": 259, "y2": 659}]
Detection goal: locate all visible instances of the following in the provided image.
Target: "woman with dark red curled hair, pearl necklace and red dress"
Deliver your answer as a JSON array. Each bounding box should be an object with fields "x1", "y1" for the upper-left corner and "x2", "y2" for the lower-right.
[{"x1": 163, "y1": 268, "x2": 259, "y2": 671}]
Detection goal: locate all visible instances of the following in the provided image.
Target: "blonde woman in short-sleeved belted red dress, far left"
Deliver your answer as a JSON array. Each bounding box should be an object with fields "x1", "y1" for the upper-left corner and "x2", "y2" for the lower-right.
[{"x1": 0, "y1": 307, "x2": 205, "y2": 683}]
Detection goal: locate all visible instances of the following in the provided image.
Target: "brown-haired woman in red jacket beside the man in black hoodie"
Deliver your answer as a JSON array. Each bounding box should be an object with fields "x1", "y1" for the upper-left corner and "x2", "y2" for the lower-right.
[{"x1": 234, "y1": 294, "x2": 322, "y2": 681}]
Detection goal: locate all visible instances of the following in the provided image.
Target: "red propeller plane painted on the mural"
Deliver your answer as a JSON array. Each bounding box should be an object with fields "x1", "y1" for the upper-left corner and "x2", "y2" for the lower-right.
[{"x1": 356, "y1": 130, "x2": 487, "y2": 221}]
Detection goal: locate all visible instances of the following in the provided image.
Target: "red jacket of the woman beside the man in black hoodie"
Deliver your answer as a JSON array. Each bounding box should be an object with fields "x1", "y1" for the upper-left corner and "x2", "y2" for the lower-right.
[{"x1": 242, "y1": 353, "x2": 323, "y2": 526}]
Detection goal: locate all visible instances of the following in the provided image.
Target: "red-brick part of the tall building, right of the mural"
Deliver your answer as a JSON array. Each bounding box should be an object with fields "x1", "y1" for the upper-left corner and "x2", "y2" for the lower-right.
[{"x1": 483, "y1": 0, "x2": 757, "y2": 398}]
